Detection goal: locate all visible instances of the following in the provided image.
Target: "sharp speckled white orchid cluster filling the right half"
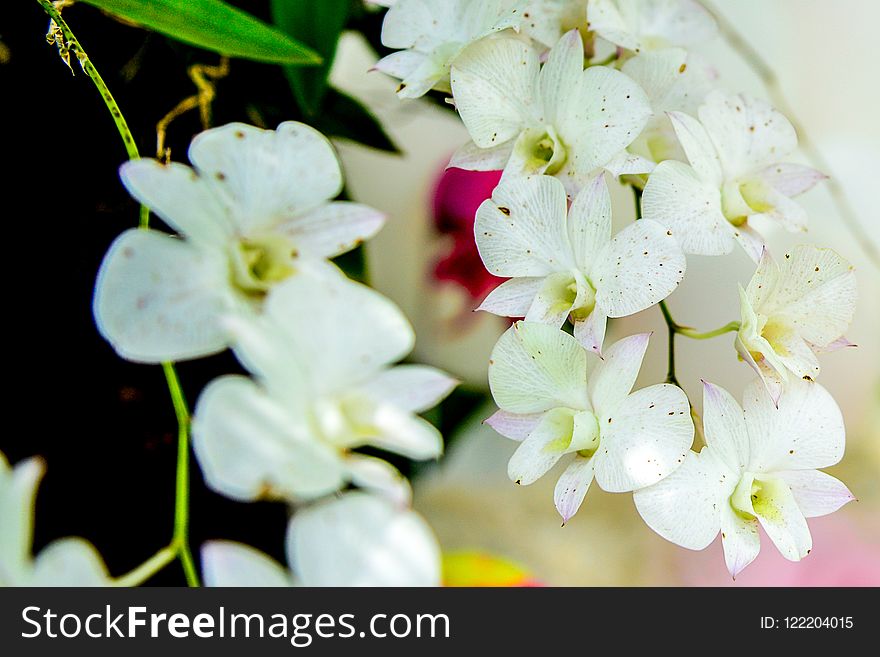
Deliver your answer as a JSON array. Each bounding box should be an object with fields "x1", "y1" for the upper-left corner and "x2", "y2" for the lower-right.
[{"x1": 377, "y1": 0, "x2": 856, "y2": 576}]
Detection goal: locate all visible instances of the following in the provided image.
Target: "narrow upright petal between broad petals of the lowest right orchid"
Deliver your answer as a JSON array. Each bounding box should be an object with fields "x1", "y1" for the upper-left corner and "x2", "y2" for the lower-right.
[{"x1": 703, "y1": 381, "x2": 749, "y2": 477}]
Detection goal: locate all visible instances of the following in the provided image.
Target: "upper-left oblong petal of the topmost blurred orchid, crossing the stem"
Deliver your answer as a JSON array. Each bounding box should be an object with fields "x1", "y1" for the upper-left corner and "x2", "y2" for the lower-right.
[{"x1": 119, "y1": 158, "x2": 235, "y2": 247}]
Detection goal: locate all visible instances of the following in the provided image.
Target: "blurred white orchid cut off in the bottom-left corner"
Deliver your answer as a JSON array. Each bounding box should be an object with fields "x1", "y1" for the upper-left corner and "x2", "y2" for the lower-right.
[{"x1": 0, "y1": 452, "x2": 111, "y2": 586}]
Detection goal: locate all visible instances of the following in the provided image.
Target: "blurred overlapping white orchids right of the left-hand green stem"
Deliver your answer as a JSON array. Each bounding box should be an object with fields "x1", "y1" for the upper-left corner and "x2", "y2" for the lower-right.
[{"x1": 94, "y1": 122, "x2": 456, "y2": 585}]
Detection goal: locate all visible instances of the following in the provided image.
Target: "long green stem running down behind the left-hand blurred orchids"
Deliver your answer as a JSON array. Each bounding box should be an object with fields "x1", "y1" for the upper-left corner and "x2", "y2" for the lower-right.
[{"x1": 37, "y1": 0, "x2": 199, "y2": 586}]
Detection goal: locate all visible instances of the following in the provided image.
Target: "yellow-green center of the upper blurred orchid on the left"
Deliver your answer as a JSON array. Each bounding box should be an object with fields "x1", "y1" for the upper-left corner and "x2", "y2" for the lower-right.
[{"x1": 230, "y1": 235, "x2": 297, "y2": 296}]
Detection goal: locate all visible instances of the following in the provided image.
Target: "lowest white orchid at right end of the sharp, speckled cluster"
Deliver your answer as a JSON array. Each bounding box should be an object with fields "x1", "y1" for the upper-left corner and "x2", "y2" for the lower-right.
[{"x1": 634, "y1": 380, "x2": 853, "y2": 577}]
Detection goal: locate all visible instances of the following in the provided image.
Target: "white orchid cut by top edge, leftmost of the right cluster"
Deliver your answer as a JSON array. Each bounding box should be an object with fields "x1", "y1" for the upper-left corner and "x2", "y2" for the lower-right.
[{"x1": 375, "y1": 0, "x2": 523, "y2": 98}]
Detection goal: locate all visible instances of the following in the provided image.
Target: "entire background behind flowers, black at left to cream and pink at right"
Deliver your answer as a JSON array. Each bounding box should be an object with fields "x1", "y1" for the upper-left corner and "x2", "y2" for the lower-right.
[{"x1": 0, "y1": 0, "x2": 880, "y2": 586}]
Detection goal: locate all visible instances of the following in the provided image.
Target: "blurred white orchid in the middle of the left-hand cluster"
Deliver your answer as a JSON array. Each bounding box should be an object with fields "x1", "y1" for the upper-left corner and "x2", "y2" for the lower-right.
[{"x1": 193, "y1": 273, "x2": 456, "y2": 501}]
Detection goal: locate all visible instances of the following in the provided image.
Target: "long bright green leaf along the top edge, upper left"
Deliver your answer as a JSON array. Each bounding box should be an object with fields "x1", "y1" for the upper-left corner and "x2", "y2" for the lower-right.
[{"x1": 82, "y1": 0, "x2": 322, "y2": 65}]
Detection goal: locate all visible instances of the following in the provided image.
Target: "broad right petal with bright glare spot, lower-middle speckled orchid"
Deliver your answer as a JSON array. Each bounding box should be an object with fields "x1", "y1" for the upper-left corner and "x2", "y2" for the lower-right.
[{"x1": 593, "y1": 383, "x2": 694, "y2": 493}]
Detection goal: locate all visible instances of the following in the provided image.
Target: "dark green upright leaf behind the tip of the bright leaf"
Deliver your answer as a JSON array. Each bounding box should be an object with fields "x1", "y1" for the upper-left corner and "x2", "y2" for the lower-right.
[{"x1": 271, "y1": 0, "x2": 351, "y2": 118}]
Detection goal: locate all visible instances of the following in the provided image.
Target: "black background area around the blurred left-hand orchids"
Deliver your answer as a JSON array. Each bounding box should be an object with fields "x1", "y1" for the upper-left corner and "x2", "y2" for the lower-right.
[{"x1": 0, "y1": 0, "x2": 478, "y2": 585}]
